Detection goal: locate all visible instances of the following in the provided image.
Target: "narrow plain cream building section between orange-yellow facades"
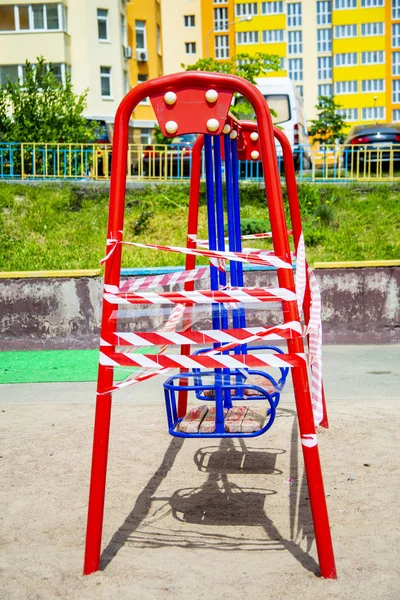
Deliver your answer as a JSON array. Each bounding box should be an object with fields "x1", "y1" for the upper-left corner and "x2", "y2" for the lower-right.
[{"x1": 161, "y1": 0, "x2": 205, "y2": 74}]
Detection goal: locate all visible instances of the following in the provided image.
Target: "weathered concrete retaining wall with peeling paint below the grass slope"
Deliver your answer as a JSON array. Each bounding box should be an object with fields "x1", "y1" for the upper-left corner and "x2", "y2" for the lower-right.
[{"x1": 0, "y1": 267, "x2": 400, "y2": 350}]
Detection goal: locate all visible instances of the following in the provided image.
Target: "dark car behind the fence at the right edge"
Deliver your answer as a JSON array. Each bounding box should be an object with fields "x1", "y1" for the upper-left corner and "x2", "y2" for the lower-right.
[{"x1": 343, "y1": 123, "x2": 400, "y2": 171}]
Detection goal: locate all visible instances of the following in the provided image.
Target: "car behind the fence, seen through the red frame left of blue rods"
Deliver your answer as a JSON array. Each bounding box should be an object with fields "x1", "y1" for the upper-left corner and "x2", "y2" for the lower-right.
[{"x1": 143, "y1": 133, "x2": 197, "y2": 178}]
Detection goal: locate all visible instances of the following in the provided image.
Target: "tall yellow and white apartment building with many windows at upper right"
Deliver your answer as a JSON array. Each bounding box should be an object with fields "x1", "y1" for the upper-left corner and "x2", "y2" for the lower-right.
[{"x1": 195, "y1": 0, "x2": 400, "y2": 125}]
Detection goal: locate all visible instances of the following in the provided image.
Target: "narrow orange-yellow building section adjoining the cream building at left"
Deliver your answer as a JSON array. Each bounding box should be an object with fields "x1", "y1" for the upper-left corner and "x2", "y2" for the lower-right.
[{"x1": 127, "y1": 0, "x2": 163, "y2": 144}]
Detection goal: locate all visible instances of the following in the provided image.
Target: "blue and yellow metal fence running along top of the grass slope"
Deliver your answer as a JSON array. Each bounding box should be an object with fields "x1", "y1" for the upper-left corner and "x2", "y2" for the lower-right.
[{"x1": 0, "y1": 143, "x2": 400, "y2": 183}]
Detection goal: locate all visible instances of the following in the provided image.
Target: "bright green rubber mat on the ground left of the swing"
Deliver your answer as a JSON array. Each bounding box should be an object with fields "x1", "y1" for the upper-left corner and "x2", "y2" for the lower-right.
[{"x1": 0, "y1": 347, "x2": 157, "y2": 384}]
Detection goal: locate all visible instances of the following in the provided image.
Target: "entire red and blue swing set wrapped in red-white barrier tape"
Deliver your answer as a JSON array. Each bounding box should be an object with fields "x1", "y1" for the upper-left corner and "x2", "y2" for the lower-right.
[{"x1": 84, "y1": 72, "x2": 336, "y2": 578}]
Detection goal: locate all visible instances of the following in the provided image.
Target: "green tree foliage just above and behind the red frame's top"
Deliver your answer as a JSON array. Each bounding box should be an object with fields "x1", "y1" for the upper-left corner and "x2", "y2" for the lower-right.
[{"x1": 181, "y1": 52, "x2": 281, "y2": 118}]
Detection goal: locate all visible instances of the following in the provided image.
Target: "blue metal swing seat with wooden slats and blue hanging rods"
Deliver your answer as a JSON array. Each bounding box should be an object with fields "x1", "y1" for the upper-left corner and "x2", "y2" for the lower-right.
[{"x1": 164, "y1": 129, "x2": 289, "y2": 437}]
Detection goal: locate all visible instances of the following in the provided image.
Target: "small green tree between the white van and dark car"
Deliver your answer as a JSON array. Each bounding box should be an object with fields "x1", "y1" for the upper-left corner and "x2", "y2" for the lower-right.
[{"x1": 308, "y1": 96, "x2": 346, "y2": 144}]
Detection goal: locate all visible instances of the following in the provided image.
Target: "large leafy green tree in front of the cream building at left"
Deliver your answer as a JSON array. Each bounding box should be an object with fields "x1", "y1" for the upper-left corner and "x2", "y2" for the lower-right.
[{"x1": 0, "y1": 57, "x2": 98, "y2": 143}]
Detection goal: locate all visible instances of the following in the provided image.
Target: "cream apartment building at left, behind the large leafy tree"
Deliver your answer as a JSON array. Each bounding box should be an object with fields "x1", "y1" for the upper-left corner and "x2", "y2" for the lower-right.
[{"x1": 0, "y1": 0, "x2": 129, "y2": 120}]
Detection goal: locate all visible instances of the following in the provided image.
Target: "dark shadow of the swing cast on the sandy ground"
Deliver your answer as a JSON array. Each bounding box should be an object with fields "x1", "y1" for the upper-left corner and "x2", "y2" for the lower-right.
[{"x1": 101, "y1": 409, "x2": 319, "y2": 574}]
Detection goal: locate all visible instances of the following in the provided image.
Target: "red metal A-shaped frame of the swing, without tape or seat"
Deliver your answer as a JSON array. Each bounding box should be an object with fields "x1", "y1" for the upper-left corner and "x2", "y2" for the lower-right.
[{"x1": 84, "y1": 72, "x2": 336, "y2": 578}]
